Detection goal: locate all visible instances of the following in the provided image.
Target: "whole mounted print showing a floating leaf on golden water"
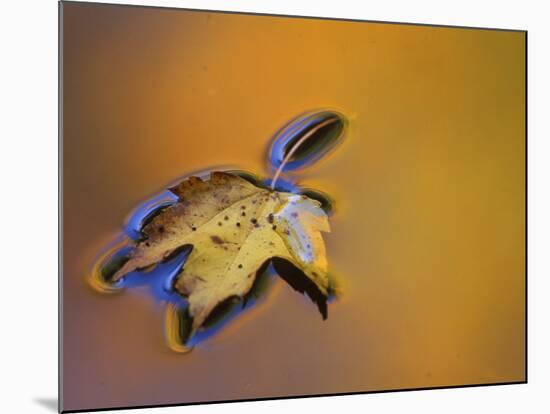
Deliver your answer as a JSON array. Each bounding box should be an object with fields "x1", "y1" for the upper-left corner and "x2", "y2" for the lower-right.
[{"x1": 59, "y1": 2, "x2": 527, "y2": 412}]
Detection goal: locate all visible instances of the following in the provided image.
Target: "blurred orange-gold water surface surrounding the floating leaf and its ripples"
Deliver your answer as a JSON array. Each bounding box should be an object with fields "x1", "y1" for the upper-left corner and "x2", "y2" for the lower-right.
[{"x1": 62, "y1": 3, "x2": 526, "y2": 409}]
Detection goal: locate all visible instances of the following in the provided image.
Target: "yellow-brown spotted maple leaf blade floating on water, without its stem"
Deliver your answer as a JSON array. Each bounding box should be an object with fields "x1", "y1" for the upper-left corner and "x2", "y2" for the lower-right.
[{"x1": 112, "y1": 172, "x2": 331, "y2": 338}]
